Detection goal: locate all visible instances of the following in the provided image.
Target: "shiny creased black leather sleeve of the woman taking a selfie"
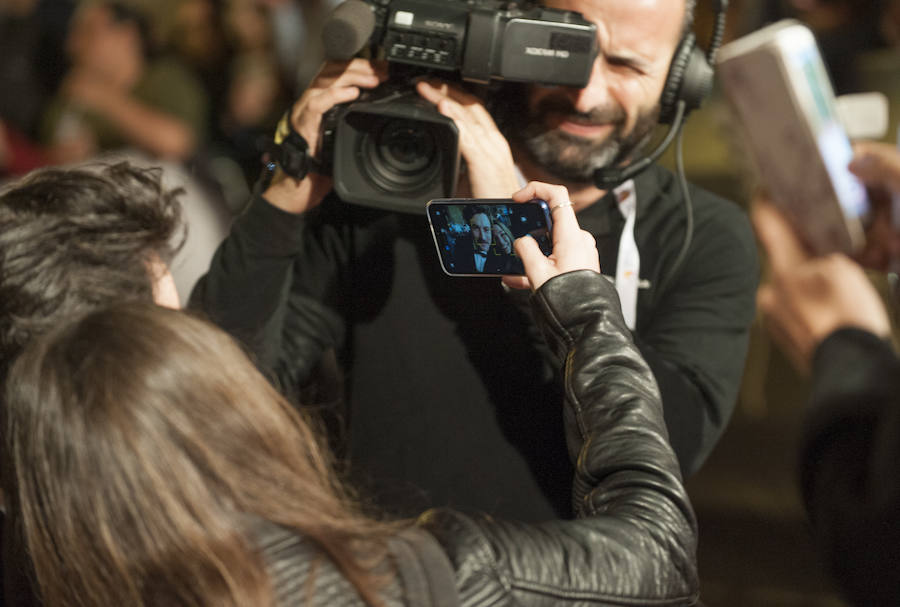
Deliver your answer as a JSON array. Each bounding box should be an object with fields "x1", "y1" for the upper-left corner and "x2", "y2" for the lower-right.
[{"x1": 422, "y1": 271, "x2": 698, "y2": 605}]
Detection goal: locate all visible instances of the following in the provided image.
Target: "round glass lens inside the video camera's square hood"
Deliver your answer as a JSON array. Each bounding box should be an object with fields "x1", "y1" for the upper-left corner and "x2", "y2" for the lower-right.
[{"x1": 360, "y1": 119, "x2": 440, "y2": 192}]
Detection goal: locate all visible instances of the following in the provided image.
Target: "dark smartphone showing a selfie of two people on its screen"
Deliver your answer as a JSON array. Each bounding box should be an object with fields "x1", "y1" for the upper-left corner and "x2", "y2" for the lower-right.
[{"x1": 425, "y1": 198, "x2": 553, "y2": 276}]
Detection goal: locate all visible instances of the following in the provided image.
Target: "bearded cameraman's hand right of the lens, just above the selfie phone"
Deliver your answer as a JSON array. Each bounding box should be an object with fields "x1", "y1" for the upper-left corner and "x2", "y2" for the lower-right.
[{"x1": 416, "y1": 81, "x2": 519, "y2": 198}]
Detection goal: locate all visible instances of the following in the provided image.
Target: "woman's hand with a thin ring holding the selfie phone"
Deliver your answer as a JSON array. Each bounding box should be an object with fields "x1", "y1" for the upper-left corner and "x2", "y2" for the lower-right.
[{"x1": 503, "y1": 181, "x2": 600, "y2": 291}]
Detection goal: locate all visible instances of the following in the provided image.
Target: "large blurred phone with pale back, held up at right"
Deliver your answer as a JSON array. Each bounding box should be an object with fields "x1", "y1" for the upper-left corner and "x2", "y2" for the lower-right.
[{"x1": 717, "y1": 19, "x2": 871, "y2": 255}]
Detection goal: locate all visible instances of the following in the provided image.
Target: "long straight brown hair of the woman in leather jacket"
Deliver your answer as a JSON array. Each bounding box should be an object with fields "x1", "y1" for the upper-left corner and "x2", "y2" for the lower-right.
[{"x1": 6, "y1": 304, "x2": 396, "y2": 606}]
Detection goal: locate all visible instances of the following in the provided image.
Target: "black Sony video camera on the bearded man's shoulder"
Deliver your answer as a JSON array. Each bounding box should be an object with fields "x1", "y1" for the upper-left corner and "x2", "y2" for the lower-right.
[{"x1": 317, "y1": 0, "x2": 597, "y2": 213}]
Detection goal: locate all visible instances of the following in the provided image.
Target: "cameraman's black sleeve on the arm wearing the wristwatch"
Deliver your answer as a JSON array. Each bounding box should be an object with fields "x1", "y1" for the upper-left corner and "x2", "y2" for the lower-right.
[{"x1": 190, "y1": 198, "x2": 348, "y2": 402}]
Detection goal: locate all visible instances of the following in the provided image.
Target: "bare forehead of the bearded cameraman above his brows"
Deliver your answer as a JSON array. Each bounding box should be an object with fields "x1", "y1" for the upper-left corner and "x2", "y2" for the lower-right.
[{"x1": 544, "y1": 0, "x2": 685, "y2": 61}]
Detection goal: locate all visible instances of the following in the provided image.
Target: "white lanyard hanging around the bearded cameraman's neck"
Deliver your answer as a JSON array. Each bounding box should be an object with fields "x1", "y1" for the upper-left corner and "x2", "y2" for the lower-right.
[{"x1": 516, "y1": 166, "x2": 641, "y2": 331}]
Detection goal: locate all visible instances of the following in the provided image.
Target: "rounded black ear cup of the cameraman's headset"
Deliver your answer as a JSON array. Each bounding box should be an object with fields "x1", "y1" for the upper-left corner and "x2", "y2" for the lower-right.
[{"x1": 659, "y1": 32, "x2": 713, "y2": 124}]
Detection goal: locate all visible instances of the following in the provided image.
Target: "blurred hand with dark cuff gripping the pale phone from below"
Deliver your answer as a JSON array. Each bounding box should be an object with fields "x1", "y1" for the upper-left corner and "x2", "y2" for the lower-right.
[{"x1": 753, "y1": 200, "x2": 891, "y2": 372}]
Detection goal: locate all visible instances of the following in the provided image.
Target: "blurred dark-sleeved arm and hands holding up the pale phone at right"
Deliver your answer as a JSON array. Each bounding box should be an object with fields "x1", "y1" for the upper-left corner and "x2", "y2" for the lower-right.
[{"x1": 754, "y1": 143, "x2": 900, "y2": 605}]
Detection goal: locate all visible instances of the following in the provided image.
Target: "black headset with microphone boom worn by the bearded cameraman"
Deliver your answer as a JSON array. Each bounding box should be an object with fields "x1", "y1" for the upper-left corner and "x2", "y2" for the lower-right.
[{"x1": 594, "y1": 0, "x2": 728, "y2": 190}]
